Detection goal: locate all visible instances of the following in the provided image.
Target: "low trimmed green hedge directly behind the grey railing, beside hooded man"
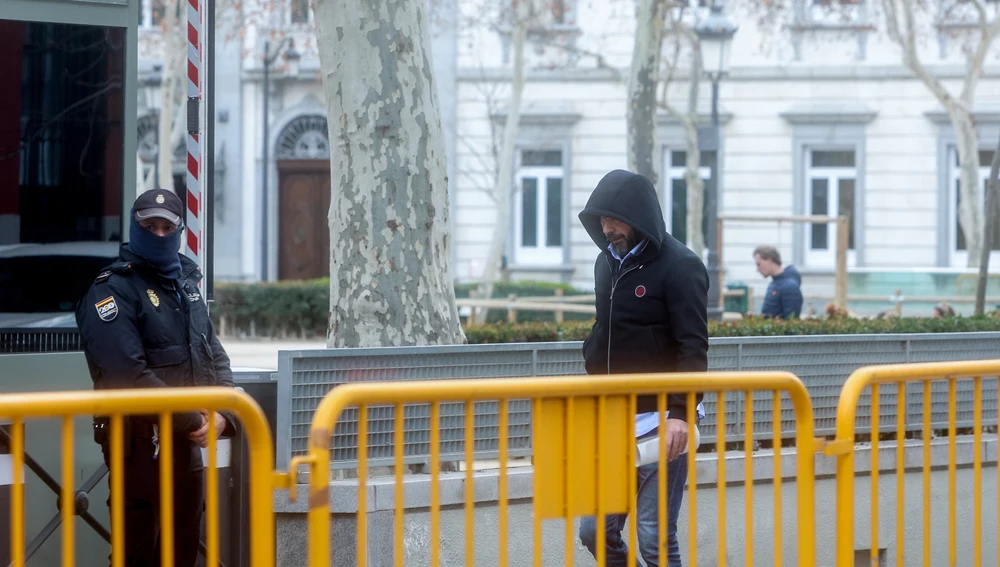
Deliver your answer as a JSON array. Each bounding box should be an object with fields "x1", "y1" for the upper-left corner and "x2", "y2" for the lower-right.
[{"x1": 465, "y1": 314, "x2": 1000, "y2": 344}]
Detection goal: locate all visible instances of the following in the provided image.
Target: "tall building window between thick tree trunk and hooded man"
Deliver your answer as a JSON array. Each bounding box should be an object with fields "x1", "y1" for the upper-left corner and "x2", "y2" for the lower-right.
[{"x1": 513, "y1": 150, "x2": 565, "y2": 265}]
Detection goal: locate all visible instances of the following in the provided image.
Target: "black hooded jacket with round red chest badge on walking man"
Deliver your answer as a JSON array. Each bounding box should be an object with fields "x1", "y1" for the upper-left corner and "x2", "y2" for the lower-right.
[{"x1": 580, "y1": 170, "x2": 708, "y2": 419}]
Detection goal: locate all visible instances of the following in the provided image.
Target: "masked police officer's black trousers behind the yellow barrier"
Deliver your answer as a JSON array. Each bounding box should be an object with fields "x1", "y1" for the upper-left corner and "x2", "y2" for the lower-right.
[{"x1": 104, "y1": 437, "x2": 205, "y2": 567}]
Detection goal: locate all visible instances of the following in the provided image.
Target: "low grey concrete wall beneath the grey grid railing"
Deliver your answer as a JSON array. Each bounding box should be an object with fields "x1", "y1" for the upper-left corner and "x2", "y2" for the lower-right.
[{"x1": 274, "y1": 436, "x2": 998, "y2": 567}]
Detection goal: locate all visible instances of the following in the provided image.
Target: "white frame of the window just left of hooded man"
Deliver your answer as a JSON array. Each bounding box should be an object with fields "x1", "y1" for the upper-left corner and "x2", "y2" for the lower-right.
[{"x1": 512, "y1": 155, "x2": 568, "y2": 266}]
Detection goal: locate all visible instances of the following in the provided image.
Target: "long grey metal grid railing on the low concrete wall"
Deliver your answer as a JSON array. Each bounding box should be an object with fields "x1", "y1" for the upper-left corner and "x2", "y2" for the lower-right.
[{"x1": 275, "y1": 333, "x2": 1000, "y2": 469}]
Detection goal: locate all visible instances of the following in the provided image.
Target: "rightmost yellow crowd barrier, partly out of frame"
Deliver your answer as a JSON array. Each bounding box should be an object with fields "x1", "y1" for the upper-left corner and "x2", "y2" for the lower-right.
[{"x1": 825, "y1": 360, "x2": 1000, "y2": 567}]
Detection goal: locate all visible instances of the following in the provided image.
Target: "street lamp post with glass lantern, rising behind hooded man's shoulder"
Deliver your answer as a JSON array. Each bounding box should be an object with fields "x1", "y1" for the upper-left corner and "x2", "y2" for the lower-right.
[{"x1": 692, "y1": 0, "x2": 738, "y2": 319}]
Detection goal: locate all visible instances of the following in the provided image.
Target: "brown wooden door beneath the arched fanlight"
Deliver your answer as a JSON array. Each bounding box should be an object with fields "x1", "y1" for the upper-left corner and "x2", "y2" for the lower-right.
[{"x1": 278, "y1": 160, "x2": 330, "y2": 280}]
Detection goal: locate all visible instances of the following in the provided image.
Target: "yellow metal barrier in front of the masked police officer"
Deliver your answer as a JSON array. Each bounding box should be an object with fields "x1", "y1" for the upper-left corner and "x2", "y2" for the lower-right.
[{"x1": 0, "y1": 387, "x2": 276, "y2": 567}]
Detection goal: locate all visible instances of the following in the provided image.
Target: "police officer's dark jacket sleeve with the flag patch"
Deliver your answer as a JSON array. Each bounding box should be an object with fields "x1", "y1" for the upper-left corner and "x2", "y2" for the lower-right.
[{"x1": 77, "y1": 281, "x2": 202, "y2": 434}]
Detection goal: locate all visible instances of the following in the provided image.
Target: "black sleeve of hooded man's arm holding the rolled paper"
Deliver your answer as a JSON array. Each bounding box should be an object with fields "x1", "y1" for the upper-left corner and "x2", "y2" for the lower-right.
[{"x1": 667, "y1": 256, "x2": 708, "y2": 420}]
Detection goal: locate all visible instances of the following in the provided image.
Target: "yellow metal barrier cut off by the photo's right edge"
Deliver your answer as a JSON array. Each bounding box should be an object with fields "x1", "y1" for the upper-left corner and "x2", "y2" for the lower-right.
[{"x1": 825, "y1": 360, "x2": 1000, "y2": 567}]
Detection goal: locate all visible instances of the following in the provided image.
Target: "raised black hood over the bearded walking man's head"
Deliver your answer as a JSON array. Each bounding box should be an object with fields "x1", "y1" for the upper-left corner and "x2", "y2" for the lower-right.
[{"x1": 580, "y1": 169, "x2": 667, "y2": 251}]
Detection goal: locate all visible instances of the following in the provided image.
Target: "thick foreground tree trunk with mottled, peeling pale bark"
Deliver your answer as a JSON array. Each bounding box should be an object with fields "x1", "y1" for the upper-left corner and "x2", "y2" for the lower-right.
[{"x1": 315, "y1": 0, "x2": 465, "y2": 348}]
